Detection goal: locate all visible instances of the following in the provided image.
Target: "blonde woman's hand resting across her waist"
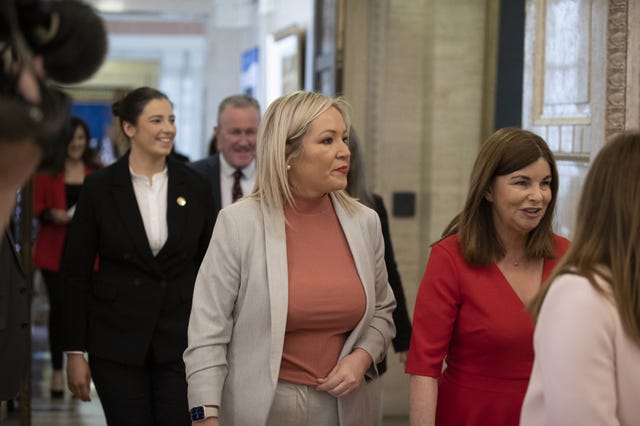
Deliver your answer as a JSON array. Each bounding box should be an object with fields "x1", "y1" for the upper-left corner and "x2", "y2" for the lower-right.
[{"x1": 316, "y1": 349, "x2": 372, "y2": 398}]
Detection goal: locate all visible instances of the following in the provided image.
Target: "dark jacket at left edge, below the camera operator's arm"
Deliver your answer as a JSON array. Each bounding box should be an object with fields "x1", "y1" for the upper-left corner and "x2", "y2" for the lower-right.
[{"x1": 0, "y1": 231, "x2": 31, "y2": 400}]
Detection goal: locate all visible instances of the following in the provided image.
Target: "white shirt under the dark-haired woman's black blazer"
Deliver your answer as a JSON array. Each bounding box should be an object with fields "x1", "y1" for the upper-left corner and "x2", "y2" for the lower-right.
[{"x1": 129, "y1": 166, "x2": 169, "y2": 256}]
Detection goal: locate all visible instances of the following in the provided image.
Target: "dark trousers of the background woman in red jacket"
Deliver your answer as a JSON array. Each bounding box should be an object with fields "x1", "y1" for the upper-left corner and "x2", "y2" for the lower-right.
[{"x1": 40, "y1": 269, "x2": 64, "y2": 370}]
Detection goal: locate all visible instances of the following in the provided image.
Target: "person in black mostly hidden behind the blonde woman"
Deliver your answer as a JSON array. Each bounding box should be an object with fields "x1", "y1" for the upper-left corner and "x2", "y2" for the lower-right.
[{"x1": 347, "y1": 129, "x2": 411, "y2": 424}]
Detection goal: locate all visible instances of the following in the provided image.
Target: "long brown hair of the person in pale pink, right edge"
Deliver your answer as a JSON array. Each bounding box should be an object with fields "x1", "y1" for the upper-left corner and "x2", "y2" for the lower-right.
[{"x1": 530, "y1": 133, "x2": 640, "y2": 344}]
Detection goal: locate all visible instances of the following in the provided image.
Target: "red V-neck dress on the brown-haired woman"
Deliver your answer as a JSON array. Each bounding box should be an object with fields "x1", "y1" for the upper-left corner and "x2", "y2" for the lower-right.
[{"x1": 406, "y1": 235, "x2": 569, "y2": 426}]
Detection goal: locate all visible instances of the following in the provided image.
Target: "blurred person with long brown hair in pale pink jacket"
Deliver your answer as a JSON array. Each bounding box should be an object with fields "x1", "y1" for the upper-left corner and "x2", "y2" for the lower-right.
[{"x1": 520, "y1": 133, "x2": 640, "y2": 426}]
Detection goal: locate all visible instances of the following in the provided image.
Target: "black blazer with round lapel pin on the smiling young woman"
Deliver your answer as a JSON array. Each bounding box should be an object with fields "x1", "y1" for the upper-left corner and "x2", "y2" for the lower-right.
[{"x1": 62, "y1": 155, "x2": 215, "y2": 365}]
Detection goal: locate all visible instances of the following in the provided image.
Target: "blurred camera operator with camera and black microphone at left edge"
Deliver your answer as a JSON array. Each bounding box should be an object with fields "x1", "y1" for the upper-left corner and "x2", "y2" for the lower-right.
[{"x1": 0, "y1": 0, "x2": 107, "y2": 401}]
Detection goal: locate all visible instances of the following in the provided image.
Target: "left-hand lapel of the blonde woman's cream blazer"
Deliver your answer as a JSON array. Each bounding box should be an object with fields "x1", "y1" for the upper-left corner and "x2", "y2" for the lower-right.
[{"x1": 260, "y1": 203, "x2": 289, "y2": 384}]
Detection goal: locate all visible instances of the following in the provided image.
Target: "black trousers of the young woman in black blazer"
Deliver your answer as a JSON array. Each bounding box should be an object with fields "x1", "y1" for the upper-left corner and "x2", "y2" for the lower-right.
[{"x1": 89, "y1": 354, "x2": 191, "y2": 426}]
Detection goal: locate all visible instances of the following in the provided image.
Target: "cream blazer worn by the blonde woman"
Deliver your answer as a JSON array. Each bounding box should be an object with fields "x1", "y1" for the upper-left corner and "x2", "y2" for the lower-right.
[{"x1": 184, "y1": 195, "x2": 395, "y2": 426}]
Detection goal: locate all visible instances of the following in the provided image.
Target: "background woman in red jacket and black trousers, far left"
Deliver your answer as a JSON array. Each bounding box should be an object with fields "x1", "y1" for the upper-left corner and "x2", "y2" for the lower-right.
[{"x1": 34, "y1": 117, "x2": 100, "y2": 398}]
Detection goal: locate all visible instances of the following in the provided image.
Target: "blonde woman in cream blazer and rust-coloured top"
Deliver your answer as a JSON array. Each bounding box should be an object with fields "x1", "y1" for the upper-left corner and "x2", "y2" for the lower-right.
[{"x1": 184, "y1": 92, "x2": 395, "y2": 426}]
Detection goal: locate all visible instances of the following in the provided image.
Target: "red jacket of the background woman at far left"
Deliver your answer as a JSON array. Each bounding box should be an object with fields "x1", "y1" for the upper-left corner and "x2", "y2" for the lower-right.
[{"x1": 33, "y1": 167, "x2": 93, "y2": 271}]
